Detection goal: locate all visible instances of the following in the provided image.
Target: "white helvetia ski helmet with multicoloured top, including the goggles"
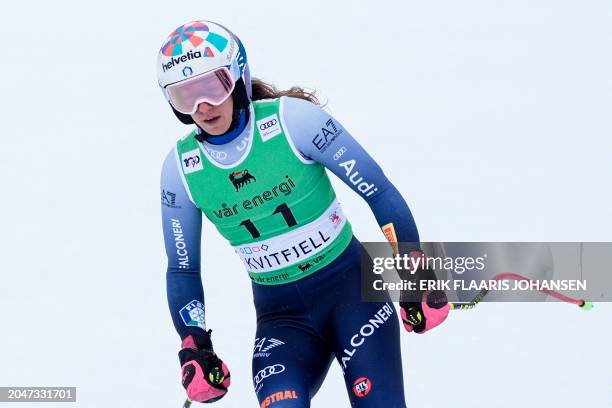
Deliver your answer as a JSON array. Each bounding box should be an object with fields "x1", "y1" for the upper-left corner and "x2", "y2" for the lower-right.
[{"x1": 157, "y1": 20, "x2": 251, "y2": 123}]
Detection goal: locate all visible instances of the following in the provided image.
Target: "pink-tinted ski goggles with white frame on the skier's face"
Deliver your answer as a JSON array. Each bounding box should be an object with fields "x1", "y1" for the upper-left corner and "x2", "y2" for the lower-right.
[{"x1": 164, "y1": 67, "x2": 234, "y2": 115}]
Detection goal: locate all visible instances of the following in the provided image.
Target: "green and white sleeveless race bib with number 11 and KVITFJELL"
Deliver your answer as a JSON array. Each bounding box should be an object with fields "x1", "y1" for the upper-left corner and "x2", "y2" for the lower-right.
[{"x1": 176, "y1": 99, "x2": 353, "y2": 285}]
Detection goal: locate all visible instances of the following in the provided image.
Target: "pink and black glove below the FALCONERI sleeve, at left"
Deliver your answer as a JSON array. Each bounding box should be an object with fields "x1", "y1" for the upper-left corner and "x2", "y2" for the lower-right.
[{"x1": 179, "y1": 330, "x2": 231, "y2": 402}]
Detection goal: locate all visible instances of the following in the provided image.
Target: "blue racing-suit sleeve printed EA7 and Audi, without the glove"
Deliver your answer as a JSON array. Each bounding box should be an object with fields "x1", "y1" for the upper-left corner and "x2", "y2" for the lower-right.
[{"x1": 283, "y1": 97, "x2": 419, "y2": 242}]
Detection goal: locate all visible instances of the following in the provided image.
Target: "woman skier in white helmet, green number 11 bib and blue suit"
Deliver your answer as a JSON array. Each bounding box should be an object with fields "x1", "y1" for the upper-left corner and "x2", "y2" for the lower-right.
[{"x1": 157, "y1": 21, "x2": 449, "y2": 408}]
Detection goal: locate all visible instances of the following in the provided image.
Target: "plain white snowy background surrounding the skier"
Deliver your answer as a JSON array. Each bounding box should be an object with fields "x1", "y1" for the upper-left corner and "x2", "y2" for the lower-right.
[{"x1": 0, "y1": 0, "x2": 612, "y2": 408}]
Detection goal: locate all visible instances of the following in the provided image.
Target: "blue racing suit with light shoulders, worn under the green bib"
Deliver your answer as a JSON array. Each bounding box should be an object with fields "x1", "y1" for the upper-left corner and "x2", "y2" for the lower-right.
[{"x1": 161, "y1": 97, "x2": 419, "y2": 408}]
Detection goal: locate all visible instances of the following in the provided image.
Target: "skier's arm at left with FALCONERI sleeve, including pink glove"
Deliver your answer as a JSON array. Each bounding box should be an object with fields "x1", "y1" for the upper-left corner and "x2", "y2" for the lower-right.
[{"x1": 161, "y1": 150, "x2": 231, "y2": 402}]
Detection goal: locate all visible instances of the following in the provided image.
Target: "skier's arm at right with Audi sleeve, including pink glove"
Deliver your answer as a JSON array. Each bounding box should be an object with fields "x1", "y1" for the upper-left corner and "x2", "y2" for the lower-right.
[{"x1": 282, "y1": 97, "x2": 450, "y2": 333}]
